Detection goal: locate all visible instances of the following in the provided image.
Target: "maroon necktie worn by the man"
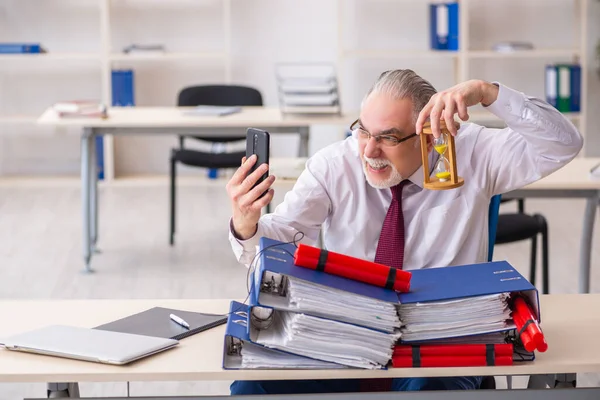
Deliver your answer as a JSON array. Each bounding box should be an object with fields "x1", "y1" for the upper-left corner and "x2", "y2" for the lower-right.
[{"x1": 375, "y1": 180, "x2": 409, "y2": 269}]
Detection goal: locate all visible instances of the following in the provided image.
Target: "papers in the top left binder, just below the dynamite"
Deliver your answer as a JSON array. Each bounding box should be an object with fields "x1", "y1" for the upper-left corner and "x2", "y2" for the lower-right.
[{"x1": 263, "y1": 273, "x2": 401, "y2": 333}]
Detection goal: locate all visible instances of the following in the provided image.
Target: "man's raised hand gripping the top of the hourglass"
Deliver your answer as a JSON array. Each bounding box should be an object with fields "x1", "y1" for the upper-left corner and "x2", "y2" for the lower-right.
[{"x1": 416, "y1": 79, "x2": 499, "y2": 138}]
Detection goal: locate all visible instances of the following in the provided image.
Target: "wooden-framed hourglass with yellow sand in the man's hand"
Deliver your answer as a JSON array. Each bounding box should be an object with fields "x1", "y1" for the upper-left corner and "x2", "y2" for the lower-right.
[{"x1": 420, "y1": 120, "x2": 465, "y2": 190}]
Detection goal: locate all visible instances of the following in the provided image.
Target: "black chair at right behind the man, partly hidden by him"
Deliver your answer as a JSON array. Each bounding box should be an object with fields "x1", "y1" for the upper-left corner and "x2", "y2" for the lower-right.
[{"x1": 496, "y1": 199, "x2": 550, "y2": 294}]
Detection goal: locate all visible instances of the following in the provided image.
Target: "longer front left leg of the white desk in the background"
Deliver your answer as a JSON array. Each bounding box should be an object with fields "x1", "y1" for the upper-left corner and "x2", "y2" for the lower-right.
[{"x1": 81, "y1": 128, "x2": 94, "y2": 272}]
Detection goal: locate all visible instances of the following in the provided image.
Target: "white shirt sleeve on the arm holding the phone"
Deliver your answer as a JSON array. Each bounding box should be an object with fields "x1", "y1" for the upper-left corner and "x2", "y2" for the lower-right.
[{"x1": 229, "y1": 154, "x2": 331, "y2": 266}]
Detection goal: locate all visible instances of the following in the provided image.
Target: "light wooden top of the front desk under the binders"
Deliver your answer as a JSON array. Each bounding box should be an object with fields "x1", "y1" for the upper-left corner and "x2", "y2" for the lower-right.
[{"x1": 0, "y1": 294, "x2": 600, "y2": 382}]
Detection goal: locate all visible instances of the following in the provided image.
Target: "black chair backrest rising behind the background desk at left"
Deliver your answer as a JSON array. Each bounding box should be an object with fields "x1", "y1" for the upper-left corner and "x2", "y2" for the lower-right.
[{"x1": 177, "y1": 85, "x2": 263, "y2": 107}]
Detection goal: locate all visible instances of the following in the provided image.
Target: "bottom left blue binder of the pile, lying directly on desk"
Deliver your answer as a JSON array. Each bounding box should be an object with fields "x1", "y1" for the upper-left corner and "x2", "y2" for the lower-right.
[{"x1": 223, "y1": 301, "x2": 345, "y2": 369}]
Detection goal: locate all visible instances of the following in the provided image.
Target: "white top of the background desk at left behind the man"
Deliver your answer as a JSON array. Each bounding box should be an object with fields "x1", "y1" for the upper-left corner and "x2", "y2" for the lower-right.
[{"x1": 37, "y1": 107, "x2": 356, "y2": 128}]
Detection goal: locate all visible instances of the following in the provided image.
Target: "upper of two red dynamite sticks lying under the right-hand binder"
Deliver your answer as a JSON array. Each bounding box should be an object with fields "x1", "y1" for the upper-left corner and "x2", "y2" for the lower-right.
[{"x1": 393, "y1": 343, "x2": 513, "y2": 357}]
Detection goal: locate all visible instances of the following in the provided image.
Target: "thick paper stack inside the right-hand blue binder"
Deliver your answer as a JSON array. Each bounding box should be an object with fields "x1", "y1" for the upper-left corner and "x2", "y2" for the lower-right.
[{"x1": 400, "y1": 293, "x2": 514, "y2": 342}]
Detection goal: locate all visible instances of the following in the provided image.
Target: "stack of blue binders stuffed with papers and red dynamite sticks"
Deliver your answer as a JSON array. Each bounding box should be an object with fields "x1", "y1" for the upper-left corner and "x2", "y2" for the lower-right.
[{"x1": 223, "y1": 237, "x2": 547, "y2": 369}]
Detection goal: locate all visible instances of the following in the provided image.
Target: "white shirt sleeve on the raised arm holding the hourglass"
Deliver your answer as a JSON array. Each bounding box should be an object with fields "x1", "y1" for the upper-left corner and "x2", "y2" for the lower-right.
[{"x1": 472, "y1": 84, "x2": 583, "y2": 196}]
